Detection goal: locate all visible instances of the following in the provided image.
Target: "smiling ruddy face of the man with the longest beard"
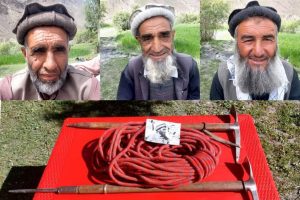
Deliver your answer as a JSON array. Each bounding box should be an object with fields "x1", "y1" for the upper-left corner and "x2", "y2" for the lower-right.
[{"x1": 236, "y1": 17, "x2": 277, "y2": 69}]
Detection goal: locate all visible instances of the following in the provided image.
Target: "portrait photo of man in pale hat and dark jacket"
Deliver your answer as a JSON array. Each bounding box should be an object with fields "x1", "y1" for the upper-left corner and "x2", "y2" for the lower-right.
[{"x1": 100, "y1": 0, "x2": 200, "y2": 100}]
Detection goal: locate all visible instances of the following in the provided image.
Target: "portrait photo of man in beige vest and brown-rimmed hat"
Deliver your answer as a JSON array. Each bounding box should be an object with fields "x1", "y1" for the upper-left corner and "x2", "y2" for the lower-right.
[{"x1": 0, "y1": 0, "x2": 100, "y2": 100}]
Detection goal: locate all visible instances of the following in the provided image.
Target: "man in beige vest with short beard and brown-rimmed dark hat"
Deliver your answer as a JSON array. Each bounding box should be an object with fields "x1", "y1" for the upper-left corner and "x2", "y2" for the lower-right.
[{"x1": 0, "y1": 3, "x2": 100, "y2": 100}]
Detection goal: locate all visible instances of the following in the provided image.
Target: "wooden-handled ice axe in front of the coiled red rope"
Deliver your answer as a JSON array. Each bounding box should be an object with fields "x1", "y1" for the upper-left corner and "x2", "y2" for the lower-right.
[{"x1": 9, "y1": 159, "x2": 259, "y2": 200}]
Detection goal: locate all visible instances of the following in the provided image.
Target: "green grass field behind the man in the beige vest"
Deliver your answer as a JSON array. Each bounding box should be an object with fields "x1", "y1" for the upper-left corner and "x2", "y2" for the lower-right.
[{"x1": 0, "y1": 43, "x2": 96, "y2": 77}]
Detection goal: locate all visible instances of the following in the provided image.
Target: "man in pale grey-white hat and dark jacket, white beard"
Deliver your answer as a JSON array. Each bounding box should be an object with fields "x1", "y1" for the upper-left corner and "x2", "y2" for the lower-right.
[{"x1": 117, "y1": 4, "x2": 200, "y2": 100}]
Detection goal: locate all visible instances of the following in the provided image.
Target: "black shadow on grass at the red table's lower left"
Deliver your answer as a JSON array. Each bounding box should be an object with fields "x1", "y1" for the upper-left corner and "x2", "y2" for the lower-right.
[{"x1": 0, "y1": 166, "x2": 45, "y2": 200}]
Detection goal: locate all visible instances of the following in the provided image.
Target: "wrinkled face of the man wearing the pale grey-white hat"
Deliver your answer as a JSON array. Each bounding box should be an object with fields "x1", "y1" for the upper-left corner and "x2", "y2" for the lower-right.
[{"x1": 136, "y1": 17, "x2": 175, "y2": 61}]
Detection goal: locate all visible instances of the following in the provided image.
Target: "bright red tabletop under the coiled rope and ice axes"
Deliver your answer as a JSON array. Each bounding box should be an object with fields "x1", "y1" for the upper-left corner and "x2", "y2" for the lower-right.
[{"x1": 34, "y1": 114, "x2": 279, "y2": 200}]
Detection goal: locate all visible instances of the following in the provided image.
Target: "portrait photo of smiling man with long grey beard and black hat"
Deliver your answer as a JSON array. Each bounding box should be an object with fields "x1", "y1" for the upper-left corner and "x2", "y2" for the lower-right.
[{"x1": 200, "y1": 0, "x2": 300, "y2": 100}]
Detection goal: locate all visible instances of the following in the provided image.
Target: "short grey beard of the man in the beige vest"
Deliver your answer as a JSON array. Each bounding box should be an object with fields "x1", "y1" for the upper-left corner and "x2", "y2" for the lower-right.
[{"x1": 28, "y1": 66, "x2": 68, "y2": 95}]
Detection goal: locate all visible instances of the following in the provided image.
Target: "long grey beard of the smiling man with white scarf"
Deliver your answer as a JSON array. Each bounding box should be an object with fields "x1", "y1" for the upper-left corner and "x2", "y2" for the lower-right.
[{"x1": 235, "y1": 54, "x2": 284, "y2": 96}]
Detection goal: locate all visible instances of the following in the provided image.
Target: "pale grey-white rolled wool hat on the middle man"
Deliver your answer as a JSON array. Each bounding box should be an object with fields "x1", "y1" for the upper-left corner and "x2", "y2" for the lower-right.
[{"x1": 129, "y1": 4, "x2": 175, "y2": 36}]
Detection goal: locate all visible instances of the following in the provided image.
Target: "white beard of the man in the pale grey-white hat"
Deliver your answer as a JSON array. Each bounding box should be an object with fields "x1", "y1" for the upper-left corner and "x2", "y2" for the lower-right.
[{"x1": 143, "y1": 55, "x2": 177, "y2": 83}]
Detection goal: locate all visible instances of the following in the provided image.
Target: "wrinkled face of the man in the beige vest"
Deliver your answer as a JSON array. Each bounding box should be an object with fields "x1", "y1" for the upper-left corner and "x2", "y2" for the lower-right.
[{"x1": 22, "y1": 26, "x2": 69, "y2": 83}]
